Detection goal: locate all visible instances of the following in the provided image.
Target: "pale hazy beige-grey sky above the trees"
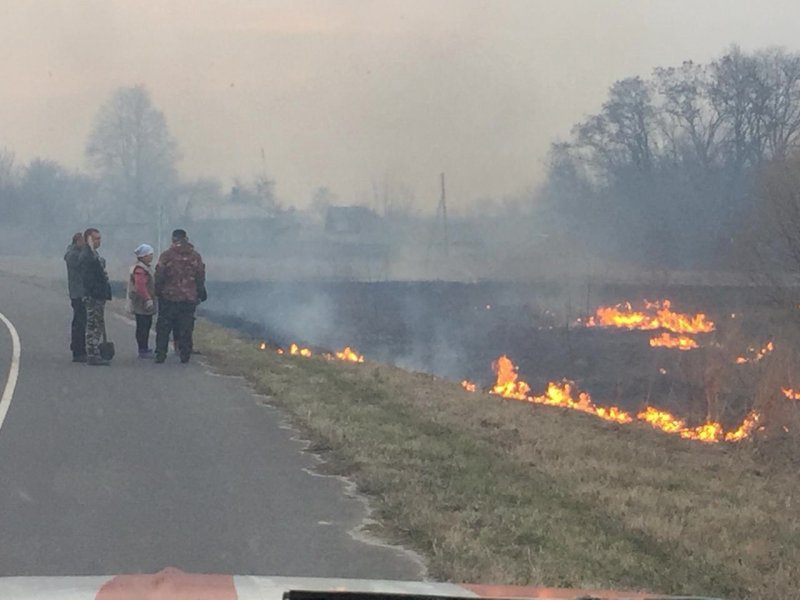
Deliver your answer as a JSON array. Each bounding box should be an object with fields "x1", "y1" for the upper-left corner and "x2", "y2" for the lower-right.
[{"x1": 0, "y1": 0, "x2": 800, "y2": 210}]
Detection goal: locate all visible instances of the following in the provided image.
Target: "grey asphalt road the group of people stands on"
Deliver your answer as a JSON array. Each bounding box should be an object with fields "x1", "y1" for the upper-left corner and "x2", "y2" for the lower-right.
[{"x1": 0, "y1": 273, "x2": 421, "y2": 579}]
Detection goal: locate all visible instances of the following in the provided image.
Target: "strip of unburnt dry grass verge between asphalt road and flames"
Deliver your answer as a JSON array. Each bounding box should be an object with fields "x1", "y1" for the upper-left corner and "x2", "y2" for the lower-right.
[{"x1": 197, "y1": 321, "x2": 800, "y2": 599}]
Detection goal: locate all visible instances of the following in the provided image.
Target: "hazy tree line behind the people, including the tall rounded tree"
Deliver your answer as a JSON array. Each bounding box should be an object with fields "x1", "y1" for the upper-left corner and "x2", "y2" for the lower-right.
[{"x1": 0, "y1": 85, "x2": 280, "y2": 251}]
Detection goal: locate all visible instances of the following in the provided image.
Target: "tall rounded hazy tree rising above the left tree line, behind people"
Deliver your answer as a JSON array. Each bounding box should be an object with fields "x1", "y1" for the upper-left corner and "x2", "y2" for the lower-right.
[{"x1": 86, "y1": 85, "x2": 178, "y2": 220}]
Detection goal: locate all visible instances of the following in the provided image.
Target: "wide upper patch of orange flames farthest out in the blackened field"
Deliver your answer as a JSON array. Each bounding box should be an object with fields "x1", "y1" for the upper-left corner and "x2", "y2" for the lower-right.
[{"x1": 586, "y1": 299, "x2": 715, "y2": 333}]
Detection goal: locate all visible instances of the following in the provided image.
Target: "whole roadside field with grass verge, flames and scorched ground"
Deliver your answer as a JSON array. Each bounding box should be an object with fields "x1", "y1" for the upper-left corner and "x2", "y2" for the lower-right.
[{"x1": 192, "y1": 282, "x2": 800, "y2": 598}]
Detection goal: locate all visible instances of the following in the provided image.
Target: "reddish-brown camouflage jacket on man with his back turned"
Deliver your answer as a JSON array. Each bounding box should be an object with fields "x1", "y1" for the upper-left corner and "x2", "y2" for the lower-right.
[{"x1": 156, "y1": 241, "x2": 206, "y2": 304}]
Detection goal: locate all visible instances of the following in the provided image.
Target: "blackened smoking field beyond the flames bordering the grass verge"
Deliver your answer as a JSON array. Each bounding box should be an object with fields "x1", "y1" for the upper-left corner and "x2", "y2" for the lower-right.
[{"x1": 203, "y1": 282, "x2": 800, "y2": 429}]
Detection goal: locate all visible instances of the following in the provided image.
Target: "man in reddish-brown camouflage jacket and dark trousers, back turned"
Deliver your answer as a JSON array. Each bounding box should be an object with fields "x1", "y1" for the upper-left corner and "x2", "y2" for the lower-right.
[{"x1": 155, "y1": 229, "x2": 207, "y2": 363}]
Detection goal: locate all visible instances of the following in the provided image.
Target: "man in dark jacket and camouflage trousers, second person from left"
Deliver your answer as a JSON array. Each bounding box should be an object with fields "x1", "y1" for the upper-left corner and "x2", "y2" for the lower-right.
[{"x1": 78, "y1": 228, "x2": 111, "y2": 366}]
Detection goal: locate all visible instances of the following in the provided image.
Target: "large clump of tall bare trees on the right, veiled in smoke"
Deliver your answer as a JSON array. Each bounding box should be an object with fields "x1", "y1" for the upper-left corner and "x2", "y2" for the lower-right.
[{"x1": 540, "y1": 47, "x2": 800, "y2": 266}]
